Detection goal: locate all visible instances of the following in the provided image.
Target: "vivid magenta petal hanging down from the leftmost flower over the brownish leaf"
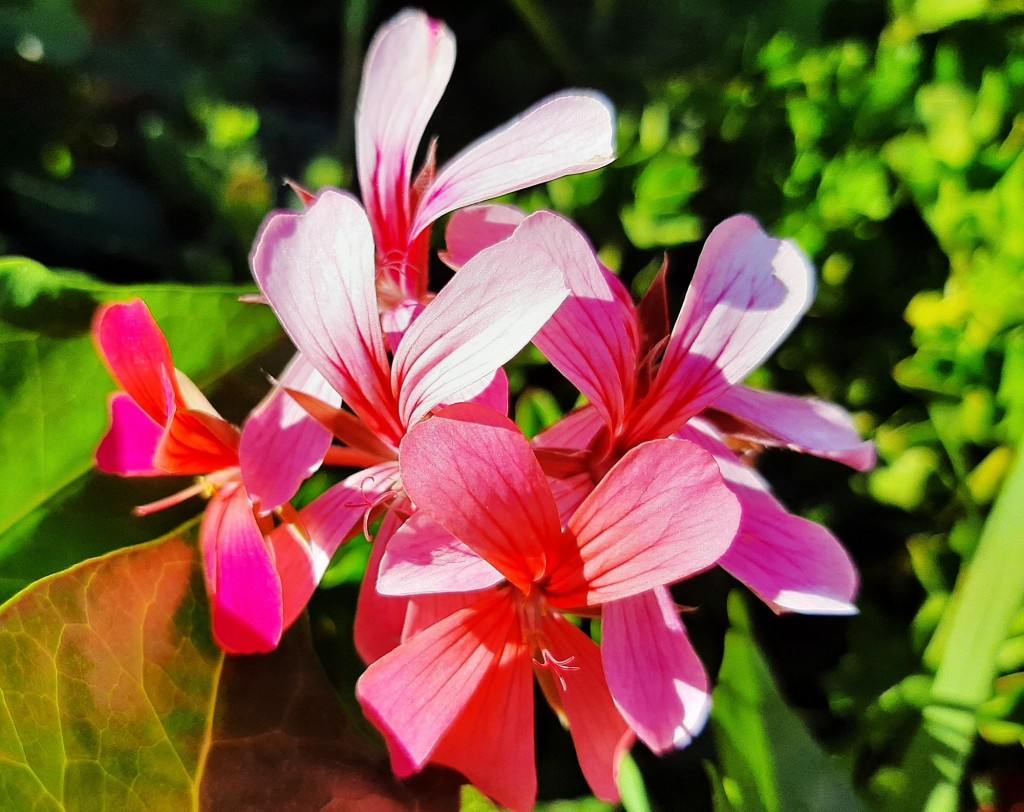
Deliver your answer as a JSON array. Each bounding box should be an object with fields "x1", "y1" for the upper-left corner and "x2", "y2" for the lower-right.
[{"x1": 200, "y1": 486, "x2": 283, "y2": 654}]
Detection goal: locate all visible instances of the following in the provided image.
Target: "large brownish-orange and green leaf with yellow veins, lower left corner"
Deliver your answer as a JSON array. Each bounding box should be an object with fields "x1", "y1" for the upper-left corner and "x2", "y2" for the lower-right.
[{"x1": 0, "y1": 536, "x2": 458, "y2": 812}]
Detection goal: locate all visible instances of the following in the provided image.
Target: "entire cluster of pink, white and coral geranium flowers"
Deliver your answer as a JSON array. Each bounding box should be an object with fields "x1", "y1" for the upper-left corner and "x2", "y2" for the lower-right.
[{"x1": 94, "y1": 11, "x2": 873, "y2": 810}]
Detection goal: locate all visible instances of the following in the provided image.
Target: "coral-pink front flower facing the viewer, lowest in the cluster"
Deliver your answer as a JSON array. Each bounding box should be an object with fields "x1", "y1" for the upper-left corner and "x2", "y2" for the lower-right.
[{"x1": 356, "y1": 404, "x2": 739, "y2": 810}]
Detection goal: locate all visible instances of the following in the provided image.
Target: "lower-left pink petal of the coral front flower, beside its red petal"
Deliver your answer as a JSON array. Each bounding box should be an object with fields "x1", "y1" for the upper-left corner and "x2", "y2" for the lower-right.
[{"x1": 355, "y1": 589, "x2": 521, "y2": 770}]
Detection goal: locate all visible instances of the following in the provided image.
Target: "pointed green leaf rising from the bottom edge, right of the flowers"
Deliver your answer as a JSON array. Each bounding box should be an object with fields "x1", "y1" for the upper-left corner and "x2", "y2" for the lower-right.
[{"x1": 712, "y1": 593, "x2": 862, "y2": 812}]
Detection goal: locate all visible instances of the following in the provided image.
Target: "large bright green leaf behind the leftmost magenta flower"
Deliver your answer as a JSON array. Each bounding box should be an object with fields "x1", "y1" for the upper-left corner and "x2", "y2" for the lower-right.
[{"x1": 0, "y1": 258, "x2": 281, "y2": 600}]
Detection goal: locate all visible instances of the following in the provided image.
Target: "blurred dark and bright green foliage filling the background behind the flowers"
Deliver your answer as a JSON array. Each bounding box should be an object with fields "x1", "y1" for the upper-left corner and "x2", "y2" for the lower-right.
[{"x1": 0, "y1": 0, "x2": 1024, "y2": 812}]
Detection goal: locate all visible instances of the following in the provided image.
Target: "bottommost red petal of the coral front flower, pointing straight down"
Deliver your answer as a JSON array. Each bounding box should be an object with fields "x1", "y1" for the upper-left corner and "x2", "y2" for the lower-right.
[{"x1": 431, "y1": 614, "x2": 537, "y2": 812}]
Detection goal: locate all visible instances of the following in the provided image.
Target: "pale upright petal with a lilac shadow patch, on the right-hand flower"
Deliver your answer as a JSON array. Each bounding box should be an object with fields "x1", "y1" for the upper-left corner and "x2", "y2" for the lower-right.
[{"x1": 628, "y1": 215, "x2": 814, "y2": 443}]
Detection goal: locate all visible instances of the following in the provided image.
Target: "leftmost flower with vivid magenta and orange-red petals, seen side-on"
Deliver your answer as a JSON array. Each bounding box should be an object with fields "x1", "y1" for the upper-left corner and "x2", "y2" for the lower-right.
[{"x1": 93, "y1": 299, "x2": 332, "y2": 653}]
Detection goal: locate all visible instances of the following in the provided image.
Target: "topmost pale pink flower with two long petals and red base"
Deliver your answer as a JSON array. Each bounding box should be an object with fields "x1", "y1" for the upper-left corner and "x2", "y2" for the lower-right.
[{"x1": 355, "y1": 9, "x2": 614, "y2": 317}]
